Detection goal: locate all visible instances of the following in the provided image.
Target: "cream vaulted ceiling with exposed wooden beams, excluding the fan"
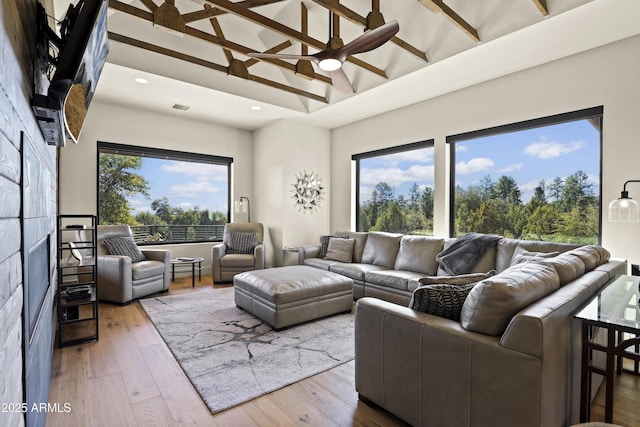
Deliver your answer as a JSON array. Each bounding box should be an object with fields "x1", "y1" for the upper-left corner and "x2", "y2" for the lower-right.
[{"x1": 55, "y1": 0, "x2": 640, "y2": 129}]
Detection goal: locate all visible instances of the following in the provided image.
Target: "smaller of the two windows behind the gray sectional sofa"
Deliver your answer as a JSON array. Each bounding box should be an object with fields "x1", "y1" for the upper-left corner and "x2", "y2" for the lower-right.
[{"x1": 352, "y1": 141, "x2": 434, "y2": 235}]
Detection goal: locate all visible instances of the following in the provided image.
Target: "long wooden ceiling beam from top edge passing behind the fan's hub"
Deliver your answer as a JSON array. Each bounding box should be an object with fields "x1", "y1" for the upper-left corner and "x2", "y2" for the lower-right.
[{"x1": 204, "y1": 0, "x2": 387, "y2": 78}]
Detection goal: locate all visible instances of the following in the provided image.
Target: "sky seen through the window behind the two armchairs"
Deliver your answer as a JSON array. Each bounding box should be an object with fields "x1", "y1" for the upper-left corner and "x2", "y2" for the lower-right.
[{"x1": 129, "y1": 157, "x2": 228, "y2": 215}]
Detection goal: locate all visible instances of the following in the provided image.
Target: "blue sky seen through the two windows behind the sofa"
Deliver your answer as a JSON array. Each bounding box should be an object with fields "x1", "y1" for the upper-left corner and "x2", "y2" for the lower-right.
[{"x1": 360, "y1": 120, "x2": 600, "y2": 202}]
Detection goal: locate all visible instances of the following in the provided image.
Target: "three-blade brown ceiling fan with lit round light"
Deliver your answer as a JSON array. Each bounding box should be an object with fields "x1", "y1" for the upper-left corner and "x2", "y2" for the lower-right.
[{"x1": 247, "y1": 21, "x2": 400, "y2": 92}]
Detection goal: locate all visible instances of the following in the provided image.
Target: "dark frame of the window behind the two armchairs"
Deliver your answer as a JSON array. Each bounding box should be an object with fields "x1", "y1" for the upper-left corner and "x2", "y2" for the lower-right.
[{"x1": 96, "y1": 141, "x2": 233, "y2": 246}]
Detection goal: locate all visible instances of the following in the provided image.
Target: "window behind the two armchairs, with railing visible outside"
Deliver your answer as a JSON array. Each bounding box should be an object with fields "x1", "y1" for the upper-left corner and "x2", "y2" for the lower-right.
[{"x1": 98, "y1": 142, "x2": 233, "y2": 244}]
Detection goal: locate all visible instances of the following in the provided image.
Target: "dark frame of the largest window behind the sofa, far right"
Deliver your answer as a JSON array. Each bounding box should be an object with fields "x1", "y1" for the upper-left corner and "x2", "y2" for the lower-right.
[{"x1": 446, "y1": 106, "x2": 604, "y2": 244}]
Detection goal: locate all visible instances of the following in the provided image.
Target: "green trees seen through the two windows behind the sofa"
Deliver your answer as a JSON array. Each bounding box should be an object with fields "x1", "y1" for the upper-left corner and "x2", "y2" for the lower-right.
[{"x1": 359, "y1": 170, "x2": 600, "y2": 244}]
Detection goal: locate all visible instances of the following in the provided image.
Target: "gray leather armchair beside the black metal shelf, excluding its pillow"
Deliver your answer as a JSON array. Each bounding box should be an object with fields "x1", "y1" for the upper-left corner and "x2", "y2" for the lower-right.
[{"x1": 92, "y1": 225, "x2": 171, "y2": 304}]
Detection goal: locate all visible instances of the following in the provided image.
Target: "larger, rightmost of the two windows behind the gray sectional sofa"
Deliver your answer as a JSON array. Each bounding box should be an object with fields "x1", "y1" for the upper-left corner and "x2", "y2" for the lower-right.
[{"x1": 447, "y1": 107, "x2": 603, "y2": 244}]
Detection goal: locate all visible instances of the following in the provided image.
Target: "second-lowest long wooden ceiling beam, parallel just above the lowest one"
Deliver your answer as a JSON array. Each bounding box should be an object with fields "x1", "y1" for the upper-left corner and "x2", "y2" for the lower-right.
[{"x1": 109, "y1": 0, "x2": 331, "y2": 85}]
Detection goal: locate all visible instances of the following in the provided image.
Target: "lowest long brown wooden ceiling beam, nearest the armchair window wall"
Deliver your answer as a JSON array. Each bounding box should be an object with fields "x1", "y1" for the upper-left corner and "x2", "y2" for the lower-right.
[{"x1": 109, "y1": 31, "x2": 329, "y2": 104}]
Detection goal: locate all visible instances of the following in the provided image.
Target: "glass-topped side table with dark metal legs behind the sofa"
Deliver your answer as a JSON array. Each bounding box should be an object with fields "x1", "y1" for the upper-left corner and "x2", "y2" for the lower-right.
[{"x1": 575, "y1": 276, "x2": 640, "y2": 423}]
